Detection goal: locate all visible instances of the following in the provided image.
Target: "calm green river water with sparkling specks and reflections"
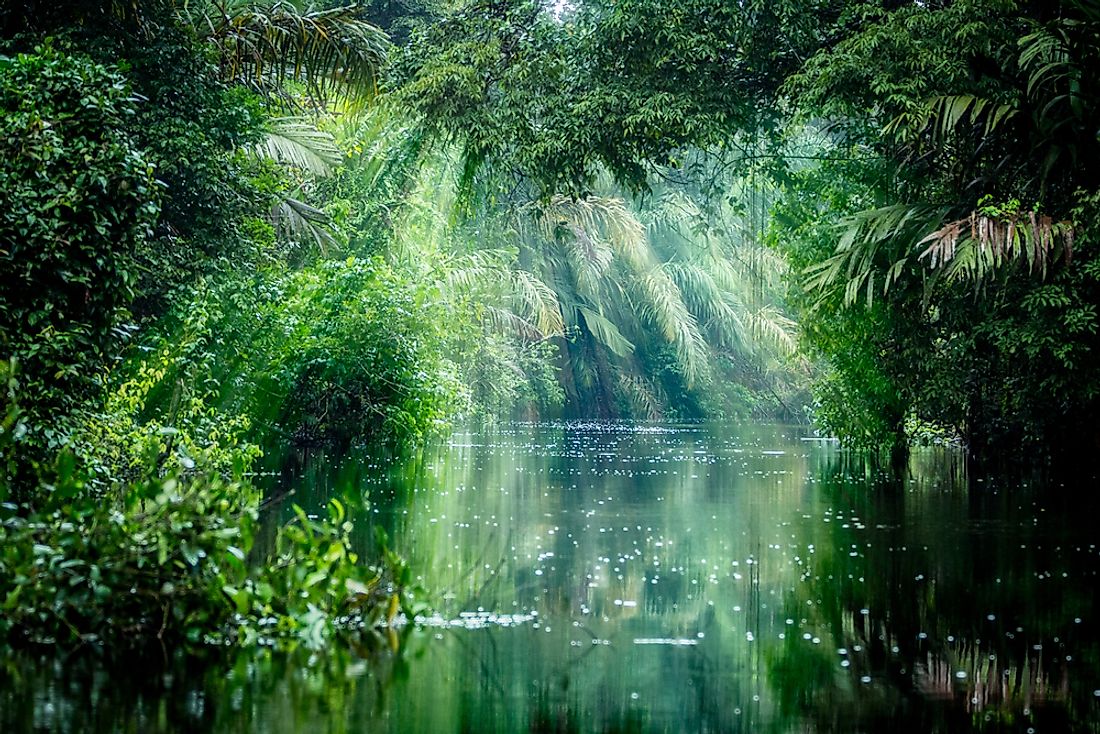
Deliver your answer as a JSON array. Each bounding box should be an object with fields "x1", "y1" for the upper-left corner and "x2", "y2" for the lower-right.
[{"x1": 0, "y1": 424, "x2": 1100, "y2": 734}]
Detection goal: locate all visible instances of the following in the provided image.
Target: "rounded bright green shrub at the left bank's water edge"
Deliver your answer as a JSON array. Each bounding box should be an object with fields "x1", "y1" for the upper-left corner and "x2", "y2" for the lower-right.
[{"x1": 250, "y1": 258, "x2": 460, "y2": 443}]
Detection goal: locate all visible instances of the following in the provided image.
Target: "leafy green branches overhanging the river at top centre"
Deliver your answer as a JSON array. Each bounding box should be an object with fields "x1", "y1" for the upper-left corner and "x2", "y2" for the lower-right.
[{"x1": 388, "y1": 0, "x2": 829, "y2": 197}]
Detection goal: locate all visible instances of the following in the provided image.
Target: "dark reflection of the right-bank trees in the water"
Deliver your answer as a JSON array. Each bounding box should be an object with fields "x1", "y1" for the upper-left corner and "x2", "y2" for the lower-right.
[{"x1": 776, "y1": 455, "x2": 1100, "y2": 731}]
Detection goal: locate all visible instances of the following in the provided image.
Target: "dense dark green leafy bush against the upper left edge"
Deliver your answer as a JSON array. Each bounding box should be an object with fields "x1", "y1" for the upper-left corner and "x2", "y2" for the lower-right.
[{"x1": 0, "y1": 46, "x2": 158, "y2": 423}]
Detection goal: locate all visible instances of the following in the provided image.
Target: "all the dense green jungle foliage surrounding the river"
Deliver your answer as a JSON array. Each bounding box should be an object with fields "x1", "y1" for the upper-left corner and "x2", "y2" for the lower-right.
[{"x1": 0, "y1": 0, "x2": 1100, "y2": 644}]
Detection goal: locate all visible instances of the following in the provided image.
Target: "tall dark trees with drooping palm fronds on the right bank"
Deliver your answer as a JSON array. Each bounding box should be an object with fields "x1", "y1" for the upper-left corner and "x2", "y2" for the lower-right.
[{"x1": 774, "y1": 0, "x2": 1100, "y2": 460}]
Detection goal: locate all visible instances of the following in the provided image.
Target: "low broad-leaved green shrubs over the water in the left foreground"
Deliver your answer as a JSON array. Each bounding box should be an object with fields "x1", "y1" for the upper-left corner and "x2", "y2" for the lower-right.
[{"x1": 0, "y1": 452, "x2": 408, "y2": 648}]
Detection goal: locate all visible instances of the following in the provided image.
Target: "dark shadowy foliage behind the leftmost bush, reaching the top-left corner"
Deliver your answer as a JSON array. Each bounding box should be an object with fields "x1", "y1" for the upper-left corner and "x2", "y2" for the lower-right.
[{"x1": 4, "y1": 0, "x2": 270, "y2": 320}]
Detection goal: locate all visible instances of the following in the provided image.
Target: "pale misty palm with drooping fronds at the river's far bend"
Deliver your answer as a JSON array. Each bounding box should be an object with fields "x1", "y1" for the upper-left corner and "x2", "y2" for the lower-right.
[{"x1": 503, "y1": 176, "x2": 794, "y2": 417}]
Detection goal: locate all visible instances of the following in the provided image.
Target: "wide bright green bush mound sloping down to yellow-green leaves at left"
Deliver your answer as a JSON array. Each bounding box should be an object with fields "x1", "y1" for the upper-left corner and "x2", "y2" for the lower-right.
[{"x1": 81, "y1": 258, "x2": 464, "y2": 453}]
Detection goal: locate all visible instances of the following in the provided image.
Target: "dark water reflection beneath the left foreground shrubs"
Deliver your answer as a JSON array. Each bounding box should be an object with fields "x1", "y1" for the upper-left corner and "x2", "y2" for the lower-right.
[{"x1": 0, "y1": 640, "x2": 407, "y2": 734}]
